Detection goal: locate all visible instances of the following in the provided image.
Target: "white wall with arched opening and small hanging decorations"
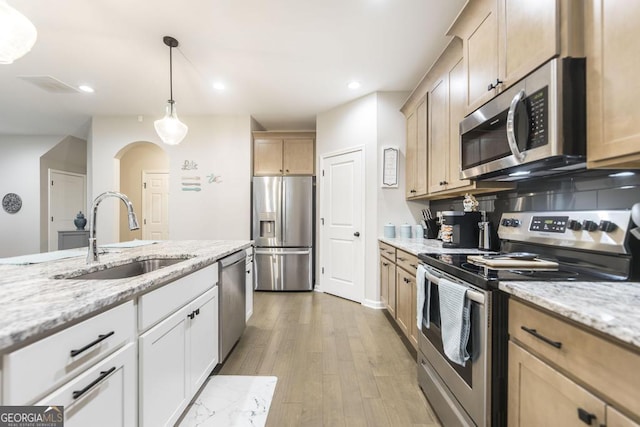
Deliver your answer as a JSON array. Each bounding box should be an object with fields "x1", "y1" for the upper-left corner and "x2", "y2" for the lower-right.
[{"x1": 88, "y1": 115, "x2": 251, "y2": 244}]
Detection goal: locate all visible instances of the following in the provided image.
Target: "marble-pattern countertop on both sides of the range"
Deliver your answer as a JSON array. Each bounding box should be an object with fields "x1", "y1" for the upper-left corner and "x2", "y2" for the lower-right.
[{"x1": 379, "y1": 237, "x2": 640, "y2": 349}]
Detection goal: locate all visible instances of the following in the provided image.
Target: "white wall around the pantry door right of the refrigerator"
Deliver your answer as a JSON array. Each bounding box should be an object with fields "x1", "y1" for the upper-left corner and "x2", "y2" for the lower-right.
[{"x1": 316, "y1": 92, "x2": 415, "y2": 307}]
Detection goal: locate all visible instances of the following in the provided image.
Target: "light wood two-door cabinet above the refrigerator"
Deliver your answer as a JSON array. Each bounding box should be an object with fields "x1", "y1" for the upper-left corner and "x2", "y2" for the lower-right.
[{"x1": 253, "y1": 132, "x2": 315, "y2": 176}]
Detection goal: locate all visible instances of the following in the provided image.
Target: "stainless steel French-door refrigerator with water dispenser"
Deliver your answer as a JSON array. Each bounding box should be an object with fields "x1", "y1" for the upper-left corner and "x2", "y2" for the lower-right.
[{"x1": 252, "y1": 176, "x2": 314, "y2": 291}]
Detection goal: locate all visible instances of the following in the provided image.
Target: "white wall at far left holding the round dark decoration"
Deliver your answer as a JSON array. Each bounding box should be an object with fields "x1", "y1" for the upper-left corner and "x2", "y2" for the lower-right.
[{"x1": 0, "y1": 135, "x2": 64, "y2": 257}]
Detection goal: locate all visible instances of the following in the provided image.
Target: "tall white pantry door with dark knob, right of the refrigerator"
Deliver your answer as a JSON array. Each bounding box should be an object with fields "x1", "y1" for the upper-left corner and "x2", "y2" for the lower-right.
[{"x1": 320, "y1": 149, "x2": 364, "y2": 302}]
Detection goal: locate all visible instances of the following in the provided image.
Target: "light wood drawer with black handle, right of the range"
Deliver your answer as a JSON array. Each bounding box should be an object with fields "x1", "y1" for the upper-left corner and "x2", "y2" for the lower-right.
[{"x1": 509, "y1": 299, "x2": 640, "y2": 414}]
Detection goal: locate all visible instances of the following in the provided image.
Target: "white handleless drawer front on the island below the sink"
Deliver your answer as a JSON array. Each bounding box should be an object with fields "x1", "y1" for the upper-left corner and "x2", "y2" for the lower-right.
[{"x1": 138, "y1": 263, "x2": 218, "y2": 332}]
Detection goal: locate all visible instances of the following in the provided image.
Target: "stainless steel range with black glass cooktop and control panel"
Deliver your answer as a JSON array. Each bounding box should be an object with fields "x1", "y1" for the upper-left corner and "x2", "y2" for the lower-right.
[{"x1": 418, "y1": 210, "x2": 640, "y2": 427}]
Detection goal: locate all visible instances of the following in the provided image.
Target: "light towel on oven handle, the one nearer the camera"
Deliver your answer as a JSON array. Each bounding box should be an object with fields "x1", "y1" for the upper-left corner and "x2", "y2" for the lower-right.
[{"x1": 438, "y1": 278, "x2": 471, "y2": 366}]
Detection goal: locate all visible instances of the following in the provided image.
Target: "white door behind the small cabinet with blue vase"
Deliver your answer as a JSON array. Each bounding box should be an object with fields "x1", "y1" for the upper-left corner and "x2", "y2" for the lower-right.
[{"x1": 48, "y1": 169, "x2": 89, "y2": 251}]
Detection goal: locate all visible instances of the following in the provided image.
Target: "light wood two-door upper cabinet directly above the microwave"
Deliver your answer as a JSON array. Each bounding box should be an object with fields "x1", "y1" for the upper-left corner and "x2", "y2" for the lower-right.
[{"x1": 448, "y1": 0, "x2": 584, "y2": 114}]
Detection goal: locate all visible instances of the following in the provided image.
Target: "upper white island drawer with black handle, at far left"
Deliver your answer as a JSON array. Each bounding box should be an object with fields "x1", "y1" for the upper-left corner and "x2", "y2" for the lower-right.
[{"x1": 3, "y1": 301, "x2": 135, "y2": 405}]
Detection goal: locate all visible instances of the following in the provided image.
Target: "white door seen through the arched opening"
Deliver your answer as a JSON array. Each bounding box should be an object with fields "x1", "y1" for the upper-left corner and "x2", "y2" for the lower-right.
[{"x1": 142, "y1": 171, "x2": 169, "y2": 240}]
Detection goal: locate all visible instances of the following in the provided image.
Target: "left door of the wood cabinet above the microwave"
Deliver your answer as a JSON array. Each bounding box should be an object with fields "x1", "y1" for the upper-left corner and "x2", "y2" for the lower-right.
[{"x1": 463, "y1": 0, "x2": 498, "y2": 113}]
